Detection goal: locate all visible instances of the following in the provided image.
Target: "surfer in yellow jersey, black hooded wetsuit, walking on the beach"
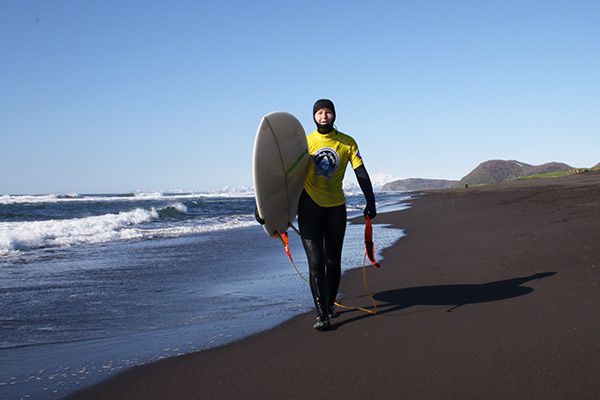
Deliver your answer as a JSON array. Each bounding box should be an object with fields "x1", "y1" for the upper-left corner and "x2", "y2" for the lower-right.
[{"x1": 298, "y1": 99, "x2": 377, "y2": 330}]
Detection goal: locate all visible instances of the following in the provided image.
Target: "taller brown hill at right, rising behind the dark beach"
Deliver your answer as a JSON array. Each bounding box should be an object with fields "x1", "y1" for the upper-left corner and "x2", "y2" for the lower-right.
[{"x1": 459, "y1": 160, "x2": 573, "y2": 186}]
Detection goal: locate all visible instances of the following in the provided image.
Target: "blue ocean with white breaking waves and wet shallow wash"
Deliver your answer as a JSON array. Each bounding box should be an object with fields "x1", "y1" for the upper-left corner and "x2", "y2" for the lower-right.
[{"x1": 0, "y1": 189, "x2": 410, "y2": 399}]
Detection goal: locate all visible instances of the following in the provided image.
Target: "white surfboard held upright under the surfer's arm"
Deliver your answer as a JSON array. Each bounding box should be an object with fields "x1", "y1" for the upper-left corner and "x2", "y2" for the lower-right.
[{"x1": 252, "y1": 112, "x2": 309, "y2": 236}]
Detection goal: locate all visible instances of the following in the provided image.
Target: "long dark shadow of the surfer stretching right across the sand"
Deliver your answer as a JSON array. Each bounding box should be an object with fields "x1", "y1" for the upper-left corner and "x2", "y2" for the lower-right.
[{"x1": 332, "y1": 272, "x2": 556, "y2": 329}]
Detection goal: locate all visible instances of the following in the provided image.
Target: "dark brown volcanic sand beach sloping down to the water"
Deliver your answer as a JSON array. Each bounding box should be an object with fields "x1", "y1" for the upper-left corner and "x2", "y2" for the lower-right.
[{"x1": 68, "y1": 173, "x2": 600, "y2": 400}]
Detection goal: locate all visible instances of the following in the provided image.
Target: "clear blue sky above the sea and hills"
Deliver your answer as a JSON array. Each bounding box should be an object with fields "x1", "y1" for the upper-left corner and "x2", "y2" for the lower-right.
[{"x1": 0, "y1": 0, "x2": 600, "y2": 194}]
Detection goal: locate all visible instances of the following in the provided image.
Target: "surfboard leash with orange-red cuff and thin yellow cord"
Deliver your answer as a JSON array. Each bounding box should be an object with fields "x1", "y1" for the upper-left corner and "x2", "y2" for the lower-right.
[{"x1": 275, "y1": 219, "x2": 381, "y2": 315}]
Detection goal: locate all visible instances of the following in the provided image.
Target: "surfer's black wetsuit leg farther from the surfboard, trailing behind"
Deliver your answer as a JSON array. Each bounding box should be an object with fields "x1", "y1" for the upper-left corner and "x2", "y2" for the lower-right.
[{"x1": 324, "y1": 205, "x2": 346, "y2": 309}]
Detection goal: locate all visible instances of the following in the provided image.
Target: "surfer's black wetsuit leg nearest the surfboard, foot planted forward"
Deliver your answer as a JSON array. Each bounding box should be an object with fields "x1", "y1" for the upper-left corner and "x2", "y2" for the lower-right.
[{"x1": 298, "y1": 192, "x2": 329, "y2": 329}]
